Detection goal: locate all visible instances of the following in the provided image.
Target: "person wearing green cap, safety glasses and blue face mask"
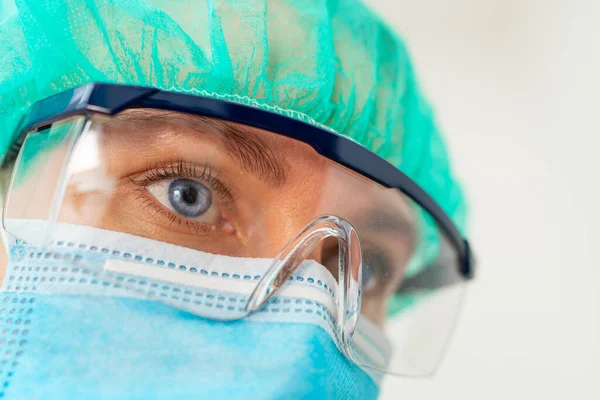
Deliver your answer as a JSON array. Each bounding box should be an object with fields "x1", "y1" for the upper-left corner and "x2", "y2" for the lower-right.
[{"x1": 0, "y1": 0, "x2": 473, "y2": 400}]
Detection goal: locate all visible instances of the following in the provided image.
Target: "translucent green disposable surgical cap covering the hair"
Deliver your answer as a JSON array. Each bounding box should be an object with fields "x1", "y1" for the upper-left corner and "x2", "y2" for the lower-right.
[{"x1": 0, "y1": 0, "x2": 465, "y2": 278}]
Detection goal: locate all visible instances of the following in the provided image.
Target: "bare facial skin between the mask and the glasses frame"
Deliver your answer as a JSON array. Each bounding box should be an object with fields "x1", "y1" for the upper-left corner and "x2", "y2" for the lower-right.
[{"x1": 1, "y1": 110, "x2": 416, "y2": 326}]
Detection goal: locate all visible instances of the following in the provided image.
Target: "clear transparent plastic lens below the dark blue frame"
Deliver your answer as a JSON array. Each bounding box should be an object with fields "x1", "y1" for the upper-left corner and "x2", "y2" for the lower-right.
[{"x1": 4, "y1": 110, "x2": 462, "y2": 375}]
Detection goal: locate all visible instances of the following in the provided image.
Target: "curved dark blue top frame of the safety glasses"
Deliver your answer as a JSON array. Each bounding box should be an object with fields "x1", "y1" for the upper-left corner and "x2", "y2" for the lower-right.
[{"x1": 16, "y1": 83, "x2": 475, "y2": 284}]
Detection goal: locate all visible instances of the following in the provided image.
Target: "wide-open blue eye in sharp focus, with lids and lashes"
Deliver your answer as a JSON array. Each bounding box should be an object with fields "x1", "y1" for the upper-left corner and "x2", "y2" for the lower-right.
[{"x1": 131, "y1": 161, "x2": 232, "y2": 234}]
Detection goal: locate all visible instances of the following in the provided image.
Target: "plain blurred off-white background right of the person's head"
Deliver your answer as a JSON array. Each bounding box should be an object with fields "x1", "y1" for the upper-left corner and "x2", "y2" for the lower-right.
[{"x1": 369, "y1": 0, "x2": 600, "y2": 400}]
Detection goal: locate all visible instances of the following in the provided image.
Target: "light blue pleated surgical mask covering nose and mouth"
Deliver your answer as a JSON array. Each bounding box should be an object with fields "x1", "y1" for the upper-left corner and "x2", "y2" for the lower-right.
[{"x1": 0, "y1": 224, "x2": 383, "y2": 400}]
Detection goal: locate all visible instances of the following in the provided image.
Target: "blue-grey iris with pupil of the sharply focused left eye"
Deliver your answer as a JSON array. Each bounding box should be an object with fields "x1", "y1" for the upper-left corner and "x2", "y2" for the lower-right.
[{"x1": 169, "y1": 179, "x2": 212, "y2": 218}]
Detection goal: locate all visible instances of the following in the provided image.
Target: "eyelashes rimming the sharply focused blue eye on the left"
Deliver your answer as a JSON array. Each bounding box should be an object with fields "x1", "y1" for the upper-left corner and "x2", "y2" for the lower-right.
[{"x1": 130, "y1": 160, "x2": 234, "y2": 235}]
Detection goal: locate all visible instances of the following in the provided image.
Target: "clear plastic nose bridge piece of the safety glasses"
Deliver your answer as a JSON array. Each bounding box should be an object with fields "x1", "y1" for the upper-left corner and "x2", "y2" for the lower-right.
[{"x1": 245, "y1": 215, "x2": 362, "y2": 361}]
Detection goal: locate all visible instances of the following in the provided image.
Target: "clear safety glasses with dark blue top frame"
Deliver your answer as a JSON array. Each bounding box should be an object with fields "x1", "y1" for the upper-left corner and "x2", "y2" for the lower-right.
[{"x1": 3, "y1": 84, "x2": 474, "y2": 376}]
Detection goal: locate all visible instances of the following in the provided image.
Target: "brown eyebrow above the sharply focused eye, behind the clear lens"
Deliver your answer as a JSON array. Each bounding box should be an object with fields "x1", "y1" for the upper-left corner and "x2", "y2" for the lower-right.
[{"x1": 116, "y1": 109, "x2": 287, "y2": 187}]
